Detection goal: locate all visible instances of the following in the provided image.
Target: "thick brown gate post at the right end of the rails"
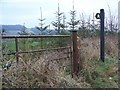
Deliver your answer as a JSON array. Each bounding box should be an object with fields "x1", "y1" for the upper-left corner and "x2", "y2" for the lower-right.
[{"x1": 72, "y1": 30, "x2": 79, "y2": 76}]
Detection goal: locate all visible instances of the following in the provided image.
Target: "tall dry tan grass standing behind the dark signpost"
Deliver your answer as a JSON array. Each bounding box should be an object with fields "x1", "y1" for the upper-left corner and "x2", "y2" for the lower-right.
[{"x1": 80, "y1": 36, "x2": 118, "y2": 60}]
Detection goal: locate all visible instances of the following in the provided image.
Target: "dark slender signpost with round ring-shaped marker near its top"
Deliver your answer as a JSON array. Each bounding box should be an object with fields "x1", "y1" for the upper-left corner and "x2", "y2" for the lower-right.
[{"x1": 95, "y1": 9, "x2": 105, "y2": 62}]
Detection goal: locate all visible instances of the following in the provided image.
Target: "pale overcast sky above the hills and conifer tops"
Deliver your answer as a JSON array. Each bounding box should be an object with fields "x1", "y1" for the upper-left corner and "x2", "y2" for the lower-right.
[{"x1": 0, "y1": 0, "x2": 120, "y2": 27}]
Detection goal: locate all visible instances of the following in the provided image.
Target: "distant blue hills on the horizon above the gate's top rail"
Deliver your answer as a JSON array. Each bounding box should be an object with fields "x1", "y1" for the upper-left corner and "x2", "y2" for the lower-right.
[{"x1": 2, "y1": 25, "x2": 56, "y2": 35}]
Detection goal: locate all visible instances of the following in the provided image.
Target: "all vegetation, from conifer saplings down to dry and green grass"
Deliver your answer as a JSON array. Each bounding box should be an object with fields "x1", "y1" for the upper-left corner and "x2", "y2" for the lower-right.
[{"x1": 2, "y1": 0, "x2": 118, "y2": 88}]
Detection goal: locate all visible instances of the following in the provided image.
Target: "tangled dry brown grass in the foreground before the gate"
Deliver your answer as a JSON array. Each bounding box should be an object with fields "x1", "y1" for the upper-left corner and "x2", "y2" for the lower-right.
[{"x1": 3, "y1": 51, "x2": 90, "y2": 88}]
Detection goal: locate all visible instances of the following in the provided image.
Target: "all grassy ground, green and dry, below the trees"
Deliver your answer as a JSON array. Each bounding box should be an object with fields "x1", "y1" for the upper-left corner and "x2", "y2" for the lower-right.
[{"x1": 3, "y1": 35, "x2": 118, "y2": 88}]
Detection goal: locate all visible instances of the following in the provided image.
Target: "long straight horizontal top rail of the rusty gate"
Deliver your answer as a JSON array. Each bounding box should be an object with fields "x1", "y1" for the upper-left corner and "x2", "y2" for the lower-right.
[{"x1": 0, "y1": 35, "x2": 70, "y2": 38}]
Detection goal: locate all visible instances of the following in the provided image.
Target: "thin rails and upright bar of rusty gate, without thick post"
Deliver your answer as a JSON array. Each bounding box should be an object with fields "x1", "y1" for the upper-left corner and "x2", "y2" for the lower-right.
[{"x1": 2, "y1": 35, "x2": 69, "y2": 63}]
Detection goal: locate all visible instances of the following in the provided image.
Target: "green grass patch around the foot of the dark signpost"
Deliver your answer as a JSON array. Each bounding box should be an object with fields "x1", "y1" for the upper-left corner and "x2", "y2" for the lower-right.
[{"x1": 82, "y1": 58, "x2": 118, "y2": 88}]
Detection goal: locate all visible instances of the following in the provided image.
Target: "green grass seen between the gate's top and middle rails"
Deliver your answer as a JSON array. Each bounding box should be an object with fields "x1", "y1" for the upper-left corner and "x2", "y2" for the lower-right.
[{"x1": 2, "y1": 38, "x2": 69, "y2": 53}]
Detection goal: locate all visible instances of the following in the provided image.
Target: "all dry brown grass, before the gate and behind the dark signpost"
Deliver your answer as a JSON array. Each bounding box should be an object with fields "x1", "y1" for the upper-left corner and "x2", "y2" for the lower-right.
[{"x1": 3, "y1": 37, "x2": 118, "y2": 88}]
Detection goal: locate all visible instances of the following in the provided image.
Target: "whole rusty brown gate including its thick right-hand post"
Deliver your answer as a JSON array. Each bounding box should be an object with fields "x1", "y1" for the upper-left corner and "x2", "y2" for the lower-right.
[{"x1": 1, "y1": 34, "x2": 76, "y2": 77}]
